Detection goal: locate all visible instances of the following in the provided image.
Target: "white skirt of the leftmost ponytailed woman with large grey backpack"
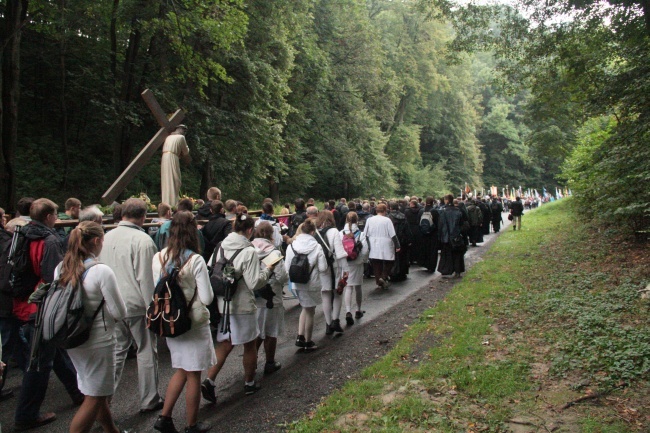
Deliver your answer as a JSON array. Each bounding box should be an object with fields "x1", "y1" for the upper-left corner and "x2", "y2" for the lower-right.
[{"x1": 67, "y1": 344, "x2": 115, "y2": 397}]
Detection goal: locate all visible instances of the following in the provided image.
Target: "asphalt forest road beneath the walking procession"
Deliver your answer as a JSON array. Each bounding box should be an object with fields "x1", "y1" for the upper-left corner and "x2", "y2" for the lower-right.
[{"x1": 0, "y1": 213, "x2": 512, "y2": 433}]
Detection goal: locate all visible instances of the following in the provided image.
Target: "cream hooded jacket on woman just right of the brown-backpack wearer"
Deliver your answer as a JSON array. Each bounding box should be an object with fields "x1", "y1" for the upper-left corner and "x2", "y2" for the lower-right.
[{"x1": 211, "y1": 232, "x2": 271, "y2": 314}]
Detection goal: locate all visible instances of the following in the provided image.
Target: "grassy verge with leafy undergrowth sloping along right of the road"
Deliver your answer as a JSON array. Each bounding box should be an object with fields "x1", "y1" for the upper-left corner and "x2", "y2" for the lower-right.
[{"x1": 285, "y1": 200, "x2": 650, "y2": 433}]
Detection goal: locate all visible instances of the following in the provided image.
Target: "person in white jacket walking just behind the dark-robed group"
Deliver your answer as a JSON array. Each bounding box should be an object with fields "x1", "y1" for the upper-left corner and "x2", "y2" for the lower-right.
[{"x1": 364, "y1": 203, "x2": 400, "y2": 289}]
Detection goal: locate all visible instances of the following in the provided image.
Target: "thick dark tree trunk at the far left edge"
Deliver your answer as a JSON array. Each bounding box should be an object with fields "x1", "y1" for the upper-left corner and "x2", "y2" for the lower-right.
[{"x1": 0, "y1": 0, "x2": 29, "y2": 211}]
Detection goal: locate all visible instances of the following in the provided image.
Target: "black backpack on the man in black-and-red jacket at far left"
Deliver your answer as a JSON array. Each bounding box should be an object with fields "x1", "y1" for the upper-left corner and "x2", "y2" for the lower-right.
[{"x1": 7, "y1": 226, "x2": 40, "y2": 299}]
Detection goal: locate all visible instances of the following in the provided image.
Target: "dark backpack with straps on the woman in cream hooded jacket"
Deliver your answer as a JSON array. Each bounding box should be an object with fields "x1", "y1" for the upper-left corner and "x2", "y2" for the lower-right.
[{"x1": 208, "y1": 243, "x2": 244, "y2": 333}]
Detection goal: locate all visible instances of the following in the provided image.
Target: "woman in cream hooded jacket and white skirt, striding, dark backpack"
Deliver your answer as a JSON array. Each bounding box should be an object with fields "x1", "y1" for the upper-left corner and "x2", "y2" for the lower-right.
[{"x1": 201, "y1": 213, "x2": 275, "y2": 403}]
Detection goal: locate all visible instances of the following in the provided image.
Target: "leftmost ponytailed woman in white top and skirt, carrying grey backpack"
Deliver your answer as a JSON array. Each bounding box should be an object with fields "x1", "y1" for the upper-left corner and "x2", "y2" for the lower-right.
[{"x1": 54, "y1": 221, "x2": 126, "y2": 433}]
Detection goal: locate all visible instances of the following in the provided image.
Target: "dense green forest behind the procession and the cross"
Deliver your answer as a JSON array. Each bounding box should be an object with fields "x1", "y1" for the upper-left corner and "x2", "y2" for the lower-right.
[{"x1": 0, "y1": 0, "x2": 650, "y2": 233}]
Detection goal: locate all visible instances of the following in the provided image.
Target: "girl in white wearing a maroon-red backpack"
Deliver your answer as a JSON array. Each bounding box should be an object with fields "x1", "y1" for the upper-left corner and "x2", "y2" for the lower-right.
[{"x1": 340, "y1": 212, "x2": 370, "y2": 326}]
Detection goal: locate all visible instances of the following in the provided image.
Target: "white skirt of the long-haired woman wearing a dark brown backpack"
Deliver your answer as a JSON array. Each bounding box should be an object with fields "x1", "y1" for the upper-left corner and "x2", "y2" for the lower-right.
[{"x1": 165, "y1": 323, "x2": 217, "y2": 371}]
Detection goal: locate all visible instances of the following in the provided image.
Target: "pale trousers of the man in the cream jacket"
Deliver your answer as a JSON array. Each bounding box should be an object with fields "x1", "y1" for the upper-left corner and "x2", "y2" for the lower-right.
[{"x1": 115, "y1": 315, "x2": 161, "y2": 410}]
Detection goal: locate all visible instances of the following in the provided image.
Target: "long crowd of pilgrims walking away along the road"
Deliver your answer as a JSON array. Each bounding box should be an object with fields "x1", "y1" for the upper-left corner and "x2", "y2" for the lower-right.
[{"x1": 0, "y1": 188, "x2": 512, "y2": 433}]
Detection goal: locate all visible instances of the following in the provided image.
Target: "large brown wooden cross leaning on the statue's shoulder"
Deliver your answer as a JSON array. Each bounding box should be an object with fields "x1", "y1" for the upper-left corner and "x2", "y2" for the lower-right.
[{"x1": 102, "y1": 89, "x2": 185, "y2": 205}]
